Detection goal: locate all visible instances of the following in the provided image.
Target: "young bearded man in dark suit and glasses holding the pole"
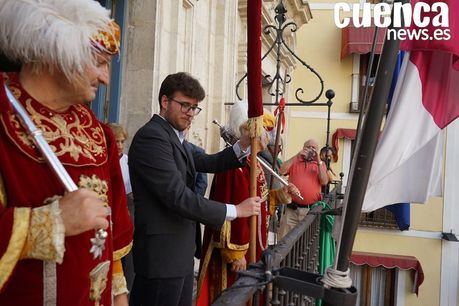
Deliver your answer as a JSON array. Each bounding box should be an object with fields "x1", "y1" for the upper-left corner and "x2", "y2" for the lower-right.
[{"x1": 128, "y1": 72, "x2": 261, "y2": 306}]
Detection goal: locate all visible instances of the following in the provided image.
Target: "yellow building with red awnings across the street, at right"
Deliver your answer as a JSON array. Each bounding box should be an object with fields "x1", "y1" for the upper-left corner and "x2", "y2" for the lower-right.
[{"x1": 286, "y1": 0, "x2": 459, "y2": 306}]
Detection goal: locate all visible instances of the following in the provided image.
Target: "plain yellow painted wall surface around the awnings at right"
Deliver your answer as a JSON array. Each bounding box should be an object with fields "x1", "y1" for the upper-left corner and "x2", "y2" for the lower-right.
[{"x1": 292, "y1": 0, "x2": 443, "y2": 306}]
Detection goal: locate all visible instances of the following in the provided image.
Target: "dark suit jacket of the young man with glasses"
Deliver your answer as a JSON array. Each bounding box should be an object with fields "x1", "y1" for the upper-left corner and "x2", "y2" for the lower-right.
[{"x1": 128, "y1": 115, "x2": 241, "y2": 278}]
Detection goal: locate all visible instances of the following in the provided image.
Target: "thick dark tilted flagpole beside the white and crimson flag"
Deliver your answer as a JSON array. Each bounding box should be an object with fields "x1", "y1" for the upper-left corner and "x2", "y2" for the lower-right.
[{"x1": 334, "y1": 0, "x2": 406, "y2": 272}]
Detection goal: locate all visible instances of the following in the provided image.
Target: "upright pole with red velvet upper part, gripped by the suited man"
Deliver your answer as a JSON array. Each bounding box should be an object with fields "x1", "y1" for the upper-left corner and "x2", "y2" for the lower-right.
[{"x1": 247, "y1": 0, "x2": 263, "y2": 263}]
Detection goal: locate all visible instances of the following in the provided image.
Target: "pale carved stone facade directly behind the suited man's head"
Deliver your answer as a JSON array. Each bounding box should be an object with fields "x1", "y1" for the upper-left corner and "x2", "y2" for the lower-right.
[{"x1": 98, "y1": 0, "x2": 311, "y2": 152}]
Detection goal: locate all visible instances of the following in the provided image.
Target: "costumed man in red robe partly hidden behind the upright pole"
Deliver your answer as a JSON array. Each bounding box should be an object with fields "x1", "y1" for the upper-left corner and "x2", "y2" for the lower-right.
[{"x1": 197, "y1": 101, "x2": 298, "y2": 306}]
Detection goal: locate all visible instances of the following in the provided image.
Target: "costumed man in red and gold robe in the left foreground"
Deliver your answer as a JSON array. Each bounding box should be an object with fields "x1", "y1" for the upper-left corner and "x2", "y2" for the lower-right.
[{"x1": 0, "y1": 0, "x2": 132, "y2": 306}]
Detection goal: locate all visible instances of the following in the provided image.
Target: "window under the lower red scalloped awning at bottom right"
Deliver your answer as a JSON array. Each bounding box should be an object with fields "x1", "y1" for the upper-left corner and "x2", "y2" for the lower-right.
[{"x1": 350, "y1": 264, "x2": 397, "y2": 306}]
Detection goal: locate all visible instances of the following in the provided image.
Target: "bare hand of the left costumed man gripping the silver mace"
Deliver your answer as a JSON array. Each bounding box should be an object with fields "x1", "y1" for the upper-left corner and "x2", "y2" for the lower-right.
[{"x1": 59, "y1": 189, "x2": 110, "y2": 236}]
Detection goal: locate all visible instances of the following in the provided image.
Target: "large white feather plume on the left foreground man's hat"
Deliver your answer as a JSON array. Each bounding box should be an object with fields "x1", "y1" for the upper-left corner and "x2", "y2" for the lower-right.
[{"x1": 0, "y1": 0, "x2": 110, "y2": 80}]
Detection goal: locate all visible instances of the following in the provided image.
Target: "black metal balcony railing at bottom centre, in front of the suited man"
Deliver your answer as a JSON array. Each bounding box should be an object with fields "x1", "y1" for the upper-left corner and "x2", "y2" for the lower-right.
[{"x1": 212, "y1": 207, "x2": 322, "y2": 305}]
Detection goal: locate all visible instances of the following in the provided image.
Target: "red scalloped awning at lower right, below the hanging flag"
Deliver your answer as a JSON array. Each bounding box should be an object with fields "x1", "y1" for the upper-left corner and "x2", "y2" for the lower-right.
[{"x1": 350, "y1": 252, "x2": 424, "y2": 294}]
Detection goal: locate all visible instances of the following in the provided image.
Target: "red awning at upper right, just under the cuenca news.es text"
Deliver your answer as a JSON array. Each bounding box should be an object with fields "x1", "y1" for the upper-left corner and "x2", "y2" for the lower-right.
[{"x1": 341, "y1": 24, "x2": 387, "y2": 59}]
